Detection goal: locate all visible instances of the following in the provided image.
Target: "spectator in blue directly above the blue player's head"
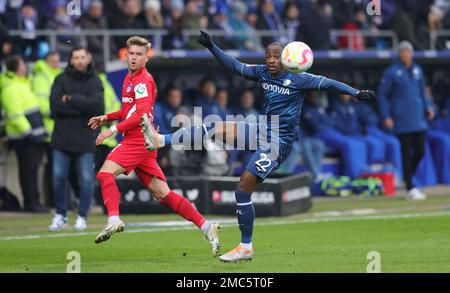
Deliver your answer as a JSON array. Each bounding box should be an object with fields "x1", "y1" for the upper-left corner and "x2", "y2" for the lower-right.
[{"x1": 256, "y1": 0, "x2": 285, "y2": 47}]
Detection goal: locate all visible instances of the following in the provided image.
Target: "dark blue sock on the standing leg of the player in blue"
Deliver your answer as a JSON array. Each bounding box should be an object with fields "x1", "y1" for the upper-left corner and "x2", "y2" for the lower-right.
[{"x1": 234, "y1": 190, "x2": 255, "y2": 243}]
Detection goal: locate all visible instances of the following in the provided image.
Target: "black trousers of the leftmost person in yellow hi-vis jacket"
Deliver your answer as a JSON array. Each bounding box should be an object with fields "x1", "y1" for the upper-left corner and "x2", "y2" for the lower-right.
[{"x1": 13, "y1": 140, "x2": 44, "y2": 210}]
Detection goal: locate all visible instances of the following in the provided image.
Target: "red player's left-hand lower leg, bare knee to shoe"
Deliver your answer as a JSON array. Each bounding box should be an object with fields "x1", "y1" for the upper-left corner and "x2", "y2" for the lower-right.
[{"x1": 95, "y1": 160, "x2": 125, "y2": 243}]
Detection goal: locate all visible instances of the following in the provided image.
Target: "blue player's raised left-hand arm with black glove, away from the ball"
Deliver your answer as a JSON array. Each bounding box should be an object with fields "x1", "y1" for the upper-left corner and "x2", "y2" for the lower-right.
[{"x1": 197, "y1": 30, "x2": 258, "y2": 79}]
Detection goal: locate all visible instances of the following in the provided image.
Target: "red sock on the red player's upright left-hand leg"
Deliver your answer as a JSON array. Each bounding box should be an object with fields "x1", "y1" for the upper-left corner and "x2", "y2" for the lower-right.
[{"x1": 97, "y1": 172, "x2": 120, "y2": 217}]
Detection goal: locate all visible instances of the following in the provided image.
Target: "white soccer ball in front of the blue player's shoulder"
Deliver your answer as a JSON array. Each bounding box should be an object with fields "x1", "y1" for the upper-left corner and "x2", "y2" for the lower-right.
[{"x1": 281, "y1": 42, "x2": 314, "y2": 73}]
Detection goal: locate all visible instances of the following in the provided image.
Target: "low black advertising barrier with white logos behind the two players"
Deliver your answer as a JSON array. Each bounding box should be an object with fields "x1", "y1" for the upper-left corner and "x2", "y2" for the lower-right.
[{"x1": 117, "y1": 173, "x2": 312, "y2": 217}]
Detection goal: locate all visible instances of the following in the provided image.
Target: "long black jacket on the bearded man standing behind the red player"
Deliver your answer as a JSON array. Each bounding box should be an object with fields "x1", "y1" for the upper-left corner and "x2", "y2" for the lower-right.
[{"x1": 50, "y1": 64, "x2": 104, "y2": 153}]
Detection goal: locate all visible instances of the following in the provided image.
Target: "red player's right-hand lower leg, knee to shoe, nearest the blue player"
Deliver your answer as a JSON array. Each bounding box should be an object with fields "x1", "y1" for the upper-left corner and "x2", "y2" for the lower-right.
[{"x1": 148, "y1": 177, "x2": 220, "y2": 256}]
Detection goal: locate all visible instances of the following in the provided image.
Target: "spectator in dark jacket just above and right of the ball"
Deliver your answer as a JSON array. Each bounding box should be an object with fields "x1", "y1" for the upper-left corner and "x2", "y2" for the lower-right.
[{"x1": 300, "y1": 0, "x2": 334, "y2": 50}]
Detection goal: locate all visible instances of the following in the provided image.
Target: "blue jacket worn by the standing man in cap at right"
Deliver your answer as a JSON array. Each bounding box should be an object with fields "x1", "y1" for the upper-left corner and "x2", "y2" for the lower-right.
[{"x1": 377, "y1": 62, "x2": 430, "y2": 133}]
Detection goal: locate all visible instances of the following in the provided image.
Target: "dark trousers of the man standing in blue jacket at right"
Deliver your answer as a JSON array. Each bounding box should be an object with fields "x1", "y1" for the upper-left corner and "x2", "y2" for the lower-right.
[{"x1": 397, "y1": 131, "x2": 426, "y2": 190}]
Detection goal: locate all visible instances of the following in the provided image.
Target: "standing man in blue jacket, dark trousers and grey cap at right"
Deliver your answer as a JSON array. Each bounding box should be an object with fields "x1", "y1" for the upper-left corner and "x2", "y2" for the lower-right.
[{"x1": 378, "y1": 41, "x2": 434, "y2": 200}]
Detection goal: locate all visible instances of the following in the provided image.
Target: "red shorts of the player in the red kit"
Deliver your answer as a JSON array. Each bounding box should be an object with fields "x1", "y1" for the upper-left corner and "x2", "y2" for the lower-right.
[{"x1": 106, "y1": 144, "x2": 167, "y2": 186}]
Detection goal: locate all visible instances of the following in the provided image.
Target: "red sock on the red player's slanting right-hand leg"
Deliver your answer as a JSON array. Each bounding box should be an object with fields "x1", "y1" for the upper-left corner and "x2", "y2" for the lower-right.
[{"x1": 159, "y1": 190, "x2": 205, "y2": 228}]
